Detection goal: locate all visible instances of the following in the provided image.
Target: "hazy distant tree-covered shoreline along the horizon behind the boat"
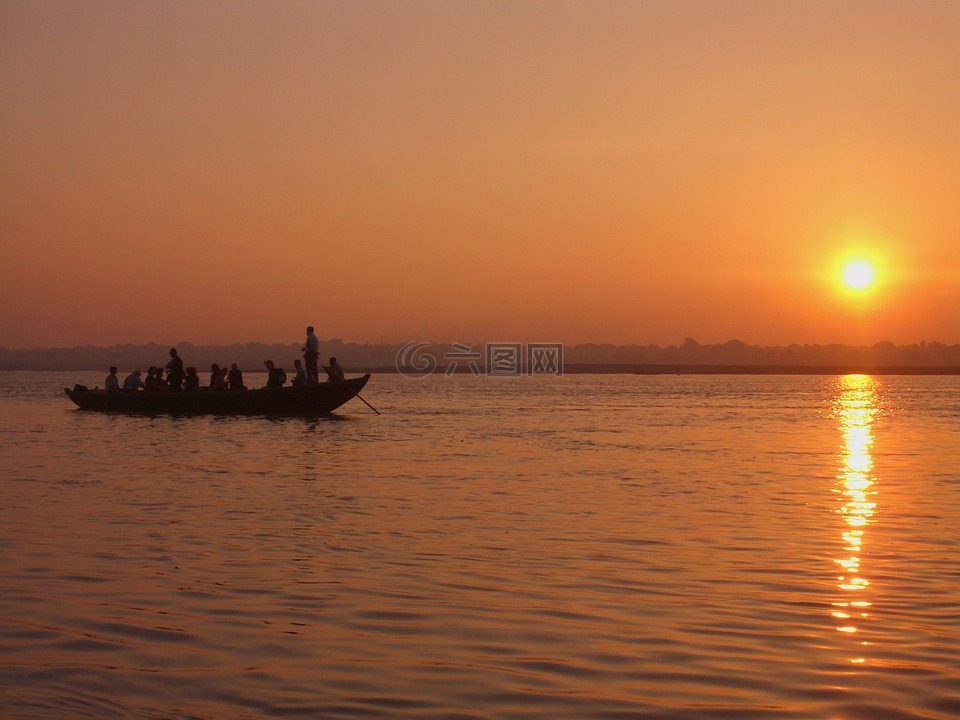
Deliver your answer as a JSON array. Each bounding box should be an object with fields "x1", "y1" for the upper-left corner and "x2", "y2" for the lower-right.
[{"x1": 0, "y1": 338, "x2": 960, "y2": 376}]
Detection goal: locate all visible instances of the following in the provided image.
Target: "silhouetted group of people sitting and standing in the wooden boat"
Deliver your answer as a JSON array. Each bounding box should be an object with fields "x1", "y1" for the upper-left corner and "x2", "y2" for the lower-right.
[{"x1": 104, "y1": 326, "x2": 344, "y2": 392}]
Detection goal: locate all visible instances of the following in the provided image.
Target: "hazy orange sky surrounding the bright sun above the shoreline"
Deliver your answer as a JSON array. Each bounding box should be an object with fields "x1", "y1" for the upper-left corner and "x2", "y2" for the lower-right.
[{"x1": 0, "y1": 0, "x2": 960, "y2": 348}]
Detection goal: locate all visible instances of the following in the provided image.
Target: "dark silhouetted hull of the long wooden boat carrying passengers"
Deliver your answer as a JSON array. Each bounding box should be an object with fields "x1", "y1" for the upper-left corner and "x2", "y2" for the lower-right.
[{"x1": 63, "y1": 373, "x2": 370, "y2": 415}]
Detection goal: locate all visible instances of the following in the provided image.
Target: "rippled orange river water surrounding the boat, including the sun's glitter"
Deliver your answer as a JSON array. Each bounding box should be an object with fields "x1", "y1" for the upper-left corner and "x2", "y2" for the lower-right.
[{"x1": 0, "y1": 373, "x2": 960, "y2": 720}]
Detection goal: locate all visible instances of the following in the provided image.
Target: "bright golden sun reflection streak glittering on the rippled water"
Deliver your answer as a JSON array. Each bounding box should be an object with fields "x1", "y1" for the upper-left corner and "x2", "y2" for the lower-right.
[{"x1": 832, "y1": 375, "x2": 878, "y2": 663}]
